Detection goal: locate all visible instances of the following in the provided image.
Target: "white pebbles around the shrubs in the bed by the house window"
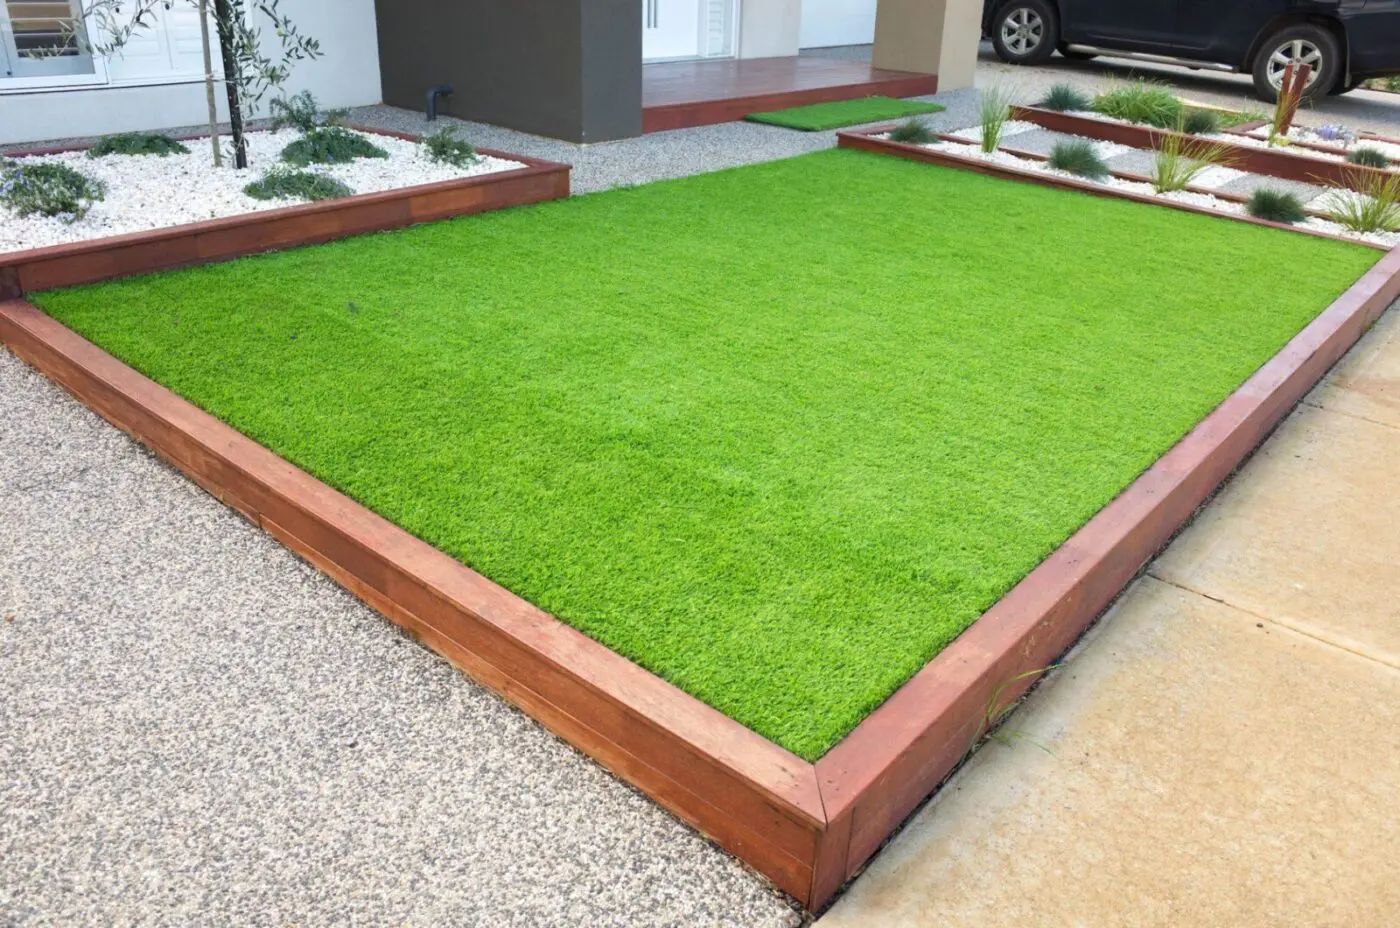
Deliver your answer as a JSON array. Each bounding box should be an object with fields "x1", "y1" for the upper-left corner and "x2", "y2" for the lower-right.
[{"x1": 0, "y1": 129, "x2": 525, "y2": 253}]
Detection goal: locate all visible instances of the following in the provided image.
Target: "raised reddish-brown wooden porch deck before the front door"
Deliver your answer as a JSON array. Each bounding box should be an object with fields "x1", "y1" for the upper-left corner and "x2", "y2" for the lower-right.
[{"x1": 641, "y1": 56, "x2": 938, "y2": 132}]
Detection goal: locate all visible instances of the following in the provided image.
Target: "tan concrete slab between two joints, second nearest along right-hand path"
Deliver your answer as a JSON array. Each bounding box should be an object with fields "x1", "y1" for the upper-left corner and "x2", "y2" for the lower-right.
[{"x1": 1149, "y1": 406, "x2": 1400, "y2": 669}]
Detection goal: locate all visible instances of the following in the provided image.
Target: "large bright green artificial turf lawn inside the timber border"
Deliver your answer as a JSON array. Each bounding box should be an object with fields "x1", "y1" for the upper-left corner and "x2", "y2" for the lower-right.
[{"x1": 35, "y1": 151, "x2": 1379, "y2": 759}]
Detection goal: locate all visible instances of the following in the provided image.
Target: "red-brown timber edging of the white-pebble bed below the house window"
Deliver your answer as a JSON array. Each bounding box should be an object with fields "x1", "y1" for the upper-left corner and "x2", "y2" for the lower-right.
[{"x1": 0, "y1": 127, "x2": 570, "y2": 300}]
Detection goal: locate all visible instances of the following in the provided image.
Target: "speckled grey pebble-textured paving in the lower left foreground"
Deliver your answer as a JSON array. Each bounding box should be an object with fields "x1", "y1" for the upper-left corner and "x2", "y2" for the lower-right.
[{"x1": 0, "y1": 349, "x2": 799, "y2": 928}]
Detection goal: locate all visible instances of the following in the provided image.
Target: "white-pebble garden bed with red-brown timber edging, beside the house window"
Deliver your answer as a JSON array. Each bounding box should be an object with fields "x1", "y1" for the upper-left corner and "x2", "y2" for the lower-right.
[{"x1": 0, "y1": 127, "x2": 570, "y2": 297}]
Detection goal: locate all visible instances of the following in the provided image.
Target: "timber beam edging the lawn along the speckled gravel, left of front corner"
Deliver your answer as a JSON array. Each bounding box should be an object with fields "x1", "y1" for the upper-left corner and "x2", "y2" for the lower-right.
[{"x1": 0, "y1": 301, "x2": 825, "y2": 899}]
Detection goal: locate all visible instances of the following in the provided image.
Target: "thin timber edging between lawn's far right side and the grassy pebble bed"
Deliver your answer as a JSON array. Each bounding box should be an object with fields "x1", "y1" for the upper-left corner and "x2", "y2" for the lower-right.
[{"x1": 836, "y1": 126, "x2": 1390, "y2": 252}]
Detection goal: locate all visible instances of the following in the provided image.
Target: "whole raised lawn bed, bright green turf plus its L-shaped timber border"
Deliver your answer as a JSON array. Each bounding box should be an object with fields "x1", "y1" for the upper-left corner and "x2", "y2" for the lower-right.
[{"x1": 0, "y1": 151, "x2": 1400, "y2": 908}]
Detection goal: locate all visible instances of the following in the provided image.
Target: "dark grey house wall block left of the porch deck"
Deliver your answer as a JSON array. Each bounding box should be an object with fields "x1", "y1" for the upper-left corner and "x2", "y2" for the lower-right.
[{"x1": 375, "y1": 0, "x2": 641, "y2": 141}]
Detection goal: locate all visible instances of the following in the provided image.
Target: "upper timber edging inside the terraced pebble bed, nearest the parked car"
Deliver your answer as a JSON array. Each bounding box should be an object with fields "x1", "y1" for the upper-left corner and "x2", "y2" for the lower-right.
[{"x1": 1011, "y1": 106, "x2": 1389, "y2": 186}]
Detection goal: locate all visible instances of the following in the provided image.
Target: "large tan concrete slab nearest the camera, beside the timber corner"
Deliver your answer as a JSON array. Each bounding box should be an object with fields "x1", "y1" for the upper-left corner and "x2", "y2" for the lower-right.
[{"x1": 818, "y1": 578, "x2": 1400, "y2": 928}]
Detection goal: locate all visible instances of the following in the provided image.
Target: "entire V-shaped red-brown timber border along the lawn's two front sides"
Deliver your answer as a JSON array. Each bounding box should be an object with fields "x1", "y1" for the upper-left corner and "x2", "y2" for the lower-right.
[{"x1": 0, "y1": 249, "x2": 1400, "y2": 910}]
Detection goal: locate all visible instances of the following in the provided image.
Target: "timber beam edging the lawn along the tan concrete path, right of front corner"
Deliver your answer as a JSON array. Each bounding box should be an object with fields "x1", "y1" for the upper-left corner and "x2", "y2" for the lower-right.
[{"x1": 812, "y1": 249, "x2": 1400, "y2": 906}]
